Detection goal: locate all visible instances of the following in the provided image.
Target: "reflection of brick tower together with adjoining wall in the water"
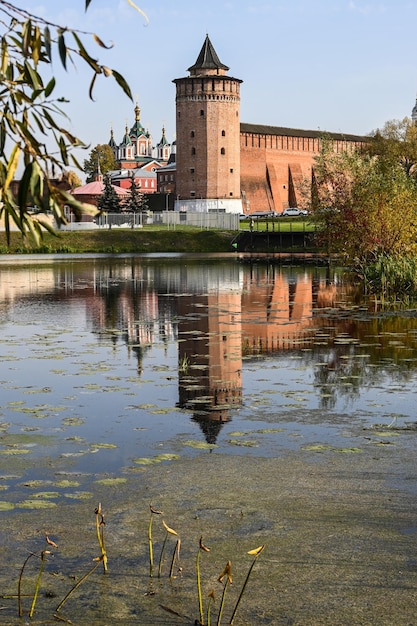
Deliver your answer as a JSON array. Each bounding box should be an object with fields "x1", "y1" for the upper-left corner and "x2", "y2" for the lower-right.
[{"x1": 178, "y1": 266, "x2": 314, "y2": 443}]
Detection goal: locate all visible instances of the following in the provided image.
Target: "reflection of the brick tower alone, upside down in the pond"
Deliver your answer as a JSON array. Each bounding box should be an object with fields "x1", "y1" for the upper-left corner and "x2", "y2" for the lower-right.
[{"x1": 178, "y1": 265, "x2": 242, "y2": 443}]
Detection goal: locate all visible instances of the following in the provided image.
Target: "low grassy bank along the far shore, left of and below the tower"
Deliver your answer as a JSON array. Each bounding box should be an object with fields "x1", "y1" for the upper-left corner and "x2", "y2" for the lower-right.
[{"x1": 0, "y1": 226, "x2": 236, "y2": 254}]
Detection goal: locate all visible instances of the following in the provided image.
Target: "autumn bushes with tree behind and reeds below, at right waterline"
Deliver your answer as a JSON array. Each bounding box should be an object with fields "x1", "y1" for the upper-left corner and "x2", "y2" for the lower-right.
[{"x1": 310, "y1": 119, "x2": 417, "y2": 297}]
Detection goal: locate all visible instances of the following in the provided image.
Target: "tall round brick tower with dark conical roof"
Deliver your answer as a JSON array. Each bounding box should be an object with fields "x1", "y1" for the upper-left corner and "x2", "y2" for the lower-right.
[{"x1": 173, "y1": 35, "x2": 243, "y2": 213}]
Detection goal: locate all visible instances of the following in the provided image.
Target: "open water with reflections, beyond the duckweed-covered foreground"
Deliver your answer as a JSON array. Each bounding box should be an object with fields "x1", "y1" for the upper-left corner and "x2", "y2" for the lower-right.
[{"x1": 0, "y1": 256, "x2": 417, "y2": 506}]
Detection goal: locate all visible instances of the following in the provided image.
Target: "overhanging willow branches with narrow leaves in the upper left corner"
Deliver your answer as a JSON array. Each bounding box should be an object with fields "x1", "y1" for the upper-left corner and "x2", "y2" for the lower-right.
[{"x1": 0, "y1": 0, "x2": 146, "y2": 240}]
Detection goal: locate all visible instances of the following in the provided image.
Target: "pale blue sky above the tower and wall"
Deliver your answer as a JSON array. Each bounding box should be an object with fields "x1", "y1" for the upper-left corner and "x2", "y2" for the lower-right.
[{"x1": 15, "y1": 0, "x2": 417, "y2": 171}]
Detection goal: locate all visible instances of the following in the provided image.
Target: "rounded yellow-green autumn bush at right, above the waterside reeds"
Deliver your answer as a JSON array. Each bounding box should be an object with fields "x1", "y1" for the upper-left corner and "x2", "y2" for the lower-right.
[{"x1": 311, "y1": 142, "x2": 417, "y2": 267}]
